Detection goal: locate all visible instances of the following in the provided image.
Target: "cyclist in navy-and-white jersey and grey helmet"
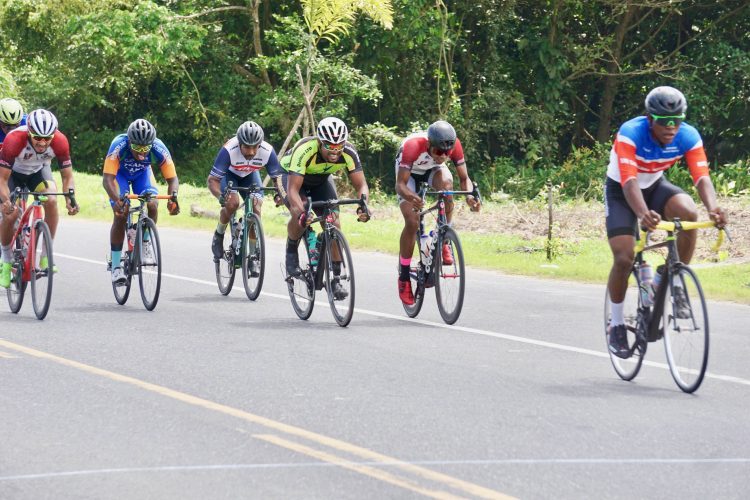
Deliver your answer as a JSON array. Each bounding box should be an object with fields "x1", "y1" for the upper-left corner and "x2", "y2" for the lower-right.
[{"x1": 207, "y1": 121, "x2": 281, "y2": 270}]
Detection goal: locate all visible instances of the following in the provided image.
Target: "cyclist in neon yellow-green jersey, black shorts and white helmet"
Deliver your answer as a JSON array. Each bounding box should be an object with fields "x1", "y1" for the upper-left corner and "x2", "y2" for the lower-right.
[{"x1": 280, "y1": 116, "x2": 370, "y2": 300}]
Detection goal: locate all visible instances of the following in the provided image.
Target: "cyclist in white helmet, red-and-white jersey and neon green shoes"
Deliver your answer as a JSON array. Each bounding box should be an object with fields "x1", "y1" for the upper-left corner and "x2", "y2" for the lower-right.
[{"x1": 0, "y1": 109, "x2": 78, "y2": 288}]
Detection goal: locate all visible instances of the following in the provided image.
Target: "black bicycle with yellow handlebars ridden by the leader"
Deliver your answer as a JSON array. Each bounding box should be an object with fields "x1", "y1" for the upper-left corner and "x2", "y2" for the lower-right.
[{"x1": 604, "y1": 219, "x2": 726, "y2": 393}]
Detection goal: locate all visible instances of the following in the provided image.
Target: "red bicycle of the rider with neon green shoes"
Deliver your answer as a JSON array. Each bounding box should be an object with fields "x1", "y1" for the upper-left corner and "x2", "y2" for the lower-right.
[{"x1": 7, "y1": 187, "x2": 77, "y2": 320}]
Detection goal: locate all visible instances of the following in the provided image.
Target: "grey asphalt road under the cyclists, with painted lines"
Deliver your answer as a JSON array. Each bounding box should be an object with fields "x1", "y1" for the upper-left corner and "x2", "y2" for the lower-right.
[{"x1": 0, "y1": 219, "x2": 750, "y2": 499}]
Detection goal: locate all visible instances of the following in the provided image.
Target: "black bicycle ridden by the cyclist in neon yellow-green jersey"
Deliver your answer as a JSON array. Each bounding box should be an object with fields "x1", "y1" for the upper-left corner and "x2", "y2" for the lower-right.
[{"x1": 282, "y1": 196, "x2": 370, "y2": 327}]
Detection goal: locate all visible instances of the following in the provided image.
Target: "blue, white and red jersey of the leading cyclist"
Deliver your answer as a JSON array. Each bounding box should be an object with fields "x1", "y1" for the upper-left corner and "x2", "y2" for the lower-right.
[{"x1": 607, "y1": 116, "x2": 708, "y2": 189}]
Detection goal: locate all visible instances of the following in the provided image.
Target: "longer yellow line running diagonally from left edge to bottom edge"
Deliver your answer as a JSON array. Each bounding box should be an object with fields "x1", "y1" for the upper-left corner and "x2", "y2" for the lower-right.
[{"x1": 0, "y1": 339, "x2": 513, "y2": 499}]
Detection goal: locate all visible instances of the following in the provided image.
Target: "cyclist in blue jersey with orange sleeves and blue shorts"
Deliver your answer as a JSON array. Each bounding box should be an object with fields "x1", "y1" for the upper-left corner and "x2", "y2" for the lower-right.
[{"x1": 102, "y1": 118, "x2": 180, "y2": 283}]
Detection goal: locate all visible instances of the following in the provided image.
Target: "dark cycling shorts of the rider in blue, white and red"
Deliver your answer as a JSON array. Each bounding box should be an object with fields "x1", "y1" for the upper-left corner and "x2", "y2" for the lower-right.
[{"x1": 604, "y1": 177, "x2": 685, "y2": 238}]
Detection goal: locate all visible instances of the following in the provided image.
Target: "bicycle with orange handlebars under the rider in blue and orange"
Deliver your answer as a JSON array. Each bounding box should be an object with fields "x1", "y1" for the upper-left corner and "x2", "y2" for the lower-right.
[{"x1": 107, "y1": 193, "x2": 177, "y2": 311}]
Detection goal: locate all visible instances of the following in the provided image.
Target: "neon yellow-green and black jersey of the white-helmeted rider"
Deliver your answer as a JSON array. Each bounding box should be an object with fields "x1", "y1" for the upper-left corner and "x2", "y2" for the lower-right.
[{"x1": 281, "y1": 136, "x2": 362, "y2": 176}]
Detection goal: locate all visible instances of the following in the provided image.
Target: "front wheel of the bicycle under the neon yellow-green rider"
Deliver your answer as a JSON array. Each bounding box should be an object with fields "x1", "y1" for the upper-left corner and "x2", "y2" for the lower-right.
[{"x1": 321, "y1": 226, "x2": 354, "y2": 326}]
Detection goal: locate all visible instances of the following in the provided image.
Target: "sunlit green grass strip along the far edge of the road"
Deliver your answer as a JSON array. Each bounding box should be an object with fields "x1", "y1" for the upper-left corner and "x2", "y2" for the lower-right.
[{"x1": 63, "y1": 172, "x2": 750, "y2": 304}]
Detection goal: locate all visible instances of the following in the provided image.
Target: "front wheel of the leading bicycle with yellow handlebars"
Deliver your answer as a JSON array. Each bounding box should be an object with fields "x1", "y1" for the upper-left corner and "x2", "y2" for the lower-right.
[{"x1": 663, "y1": 265, "x2": 708, "y2": 393}]
